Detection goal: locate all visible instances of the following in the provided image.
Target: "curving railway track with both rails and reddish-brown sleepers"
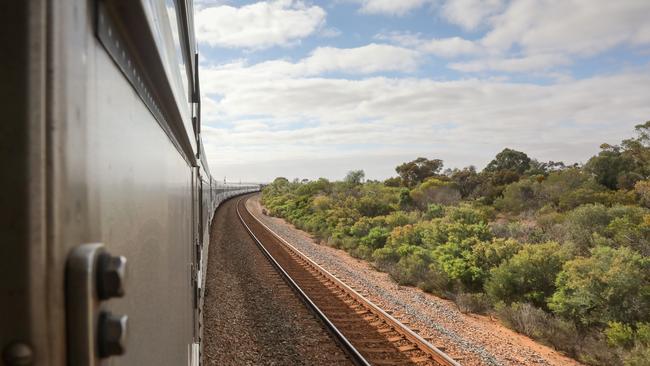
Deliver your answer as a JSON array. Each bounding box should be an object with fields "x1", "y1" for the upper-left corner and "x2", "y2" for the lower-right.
[{"x1": 237, "y1": 197, "x2": 460, "y2": 366}]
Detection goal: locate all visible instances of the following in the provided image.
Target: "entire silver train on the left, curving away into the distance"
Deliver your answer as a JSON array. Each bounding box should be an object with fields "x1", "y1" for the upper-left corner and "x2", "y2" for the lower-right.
[{"x1": 0, "y1": 0, "x2": 259, "y2": 366}]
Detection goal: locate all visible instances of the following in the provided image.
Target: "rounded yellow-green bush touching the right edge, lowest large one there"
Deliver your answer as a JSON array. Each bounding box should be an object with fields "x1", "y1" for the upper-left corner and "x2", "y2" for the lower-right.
[{"x1": 549, "y1": 247, "x2": 650, "y2": 326}]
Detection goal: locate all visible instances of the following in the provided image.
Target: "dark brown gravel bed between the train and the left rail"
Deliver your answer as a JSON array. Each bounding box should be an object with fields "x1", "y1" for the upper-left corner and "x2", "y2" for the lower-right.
[{"x1": 203, "y1": 198, "x2": 351, "y2": 366}]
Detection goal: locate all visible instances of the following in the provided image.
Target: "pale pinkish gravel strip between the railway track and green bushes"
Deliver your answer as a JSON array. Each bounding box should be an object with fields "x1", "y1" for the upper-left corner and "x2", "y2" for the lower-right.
[{"x1": 247, "y1": 195, "x2": 581, "y2": 366}]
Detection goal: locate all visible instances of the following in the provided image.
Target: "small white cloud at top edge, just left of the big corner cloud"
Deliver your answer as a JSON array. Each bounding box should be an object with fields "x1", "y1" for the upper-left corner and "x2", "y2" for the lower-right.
[{"x1": 441, "y1": 0, "x2": 504, "y2": 30}]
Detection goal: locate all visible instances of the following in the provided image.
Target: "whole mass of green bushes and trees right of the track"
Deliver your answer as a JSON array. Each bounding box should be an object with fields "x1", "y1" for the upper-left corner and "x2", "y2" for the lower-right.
[{"x1": 262, "y1": 121, "x2": 650, "y2": 365}]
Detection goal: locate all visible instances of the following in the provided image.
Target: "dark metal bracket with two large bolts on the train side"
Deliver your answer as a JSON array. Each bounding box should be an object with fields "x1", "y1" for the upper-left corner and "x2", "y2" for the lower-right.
[{"x1": 66, "y1": 243, "x2": 128, "y2": 366}]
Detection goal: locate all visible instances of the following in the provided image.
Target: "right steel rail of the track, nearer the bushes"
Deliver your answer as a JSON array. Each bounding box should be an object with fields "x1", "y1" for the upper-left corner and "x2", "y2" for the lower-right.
[{"x1": 239, "y1": 199, "x2": 461, "y2": 366}]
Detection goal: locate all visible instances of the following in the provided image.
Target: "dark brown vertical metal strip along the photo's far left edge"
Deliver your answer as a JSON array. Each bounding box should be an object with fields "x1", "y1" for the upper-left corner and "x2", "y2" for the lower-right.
[{"x1": 0, "y1": 0, "x2": 48, "y2": 364}]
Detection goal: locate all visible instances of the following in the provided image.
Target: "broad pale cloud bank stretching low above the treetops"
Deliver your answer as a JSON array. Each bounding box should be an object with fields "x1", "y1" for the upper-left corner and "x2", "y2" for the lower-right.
[{"x1": 202, "y1": 54, "x2": 650, "y2": 179}]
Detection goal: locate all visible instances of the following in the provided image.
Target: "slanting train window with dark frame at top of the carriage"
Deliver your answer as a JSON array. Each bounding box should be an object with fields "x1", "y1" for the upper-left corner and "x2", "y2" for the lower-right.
[{"x1": 95, "y1": 0, "x2": 198, "y2": 166}]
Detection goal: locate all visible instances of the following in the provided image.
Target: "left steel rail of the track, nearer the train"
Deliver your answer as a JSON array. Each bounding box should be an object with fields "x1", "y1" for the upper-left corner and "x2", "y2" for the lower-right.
[{"x1": 235, "y1": 198, "x2": 371, "y2": 366}]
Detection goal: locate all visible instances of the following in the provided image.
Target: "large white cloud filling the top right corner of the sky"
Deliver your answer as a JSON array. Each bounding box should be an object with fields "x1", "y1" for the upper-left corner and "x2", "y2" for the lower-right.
[{"x1": 482, "y1": 0, "x2": 650, "y2": 56}]
